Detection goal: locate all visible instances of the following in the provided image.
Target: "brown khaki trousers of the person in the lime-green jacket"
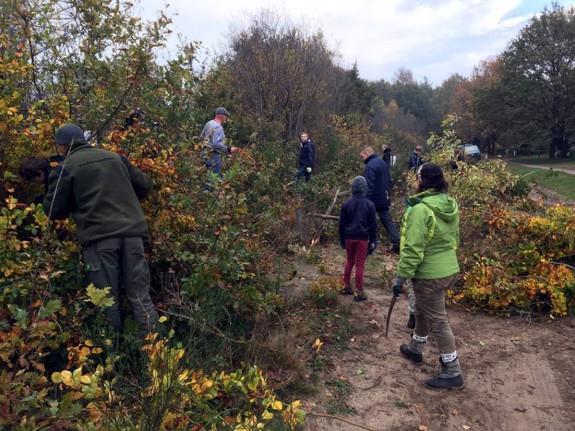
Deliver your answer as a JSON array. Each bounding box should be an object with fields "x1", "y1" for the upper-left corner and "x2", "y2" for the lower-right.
[{"x1": 413, "y1": 274, "x2": 457, "y2": 354}]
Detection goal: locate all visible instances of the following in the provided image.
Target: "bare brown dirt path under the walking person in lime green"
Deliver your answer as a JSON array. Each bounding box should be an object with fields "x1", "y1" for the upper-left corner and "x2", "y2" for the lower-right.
[{"x1": 298, "y1": 246, "x2": 575, "y2": 431}]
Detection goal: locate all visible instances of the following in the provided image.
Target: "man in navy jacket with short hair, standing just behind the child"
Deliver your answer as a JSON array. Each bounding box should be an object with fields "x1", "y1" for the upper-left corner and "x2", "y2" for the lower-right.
[{"x1": 360, "y1": 147, "x2": 399, "y2": 254}]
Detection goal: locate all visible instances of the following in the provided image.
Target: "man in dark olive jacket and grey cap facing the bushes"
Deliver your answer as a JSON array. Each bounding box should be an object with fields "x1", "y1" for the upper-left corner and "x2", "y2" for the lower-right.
[{"x1": 43, "y1": 124, "x2": 158, "y2": 334}]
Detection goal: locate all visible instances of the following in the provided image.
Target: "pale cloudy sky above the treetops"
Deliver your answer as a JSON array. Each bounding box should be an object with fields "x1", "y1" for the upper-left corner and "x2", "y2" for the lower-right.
[{"x1": 136, "y1": 0, "x2": 575, "y2": 85}]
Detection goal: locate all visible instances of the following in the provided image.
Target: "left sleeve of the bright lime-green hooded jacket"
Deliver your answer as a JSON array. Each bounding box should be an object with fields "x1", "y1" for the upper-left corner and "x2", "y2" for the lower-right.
[{"x1": 396, "y1": 204, "x2": 435, "y2": 278}]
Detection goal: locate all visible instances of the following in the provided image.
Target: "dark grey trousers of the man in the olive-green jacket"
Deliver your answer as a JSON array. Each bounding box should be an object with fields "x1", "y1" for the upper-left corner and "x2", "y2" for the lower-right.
[{"x1": 84, "y1": 237, "x2": 158, "y2": 334}]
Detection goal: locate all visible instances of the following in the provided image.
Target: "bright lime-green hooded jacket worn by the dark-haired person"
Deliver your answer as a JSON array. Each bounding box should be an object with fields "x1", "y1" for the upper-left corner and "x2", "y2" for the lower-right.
[{"x1": 396, "y1": 190, "x2": 459, "y2": 280}]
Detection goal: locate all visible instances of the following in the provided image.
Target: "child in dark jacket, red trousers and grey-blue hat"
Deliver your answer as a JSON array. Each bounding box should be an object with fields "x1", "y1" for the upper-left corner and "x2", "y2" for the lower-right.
[{"x1": 339, "y1": 177, "x2": 377, "y2": 301}]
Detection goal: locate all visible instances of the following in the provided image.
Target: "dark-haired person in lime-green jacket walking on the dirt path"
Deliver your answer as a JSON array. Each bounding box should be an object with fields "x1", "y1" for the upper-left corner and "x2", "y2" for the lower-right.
[{"x1": 393, "y1": 163, "x2": 463, "y2": 389}]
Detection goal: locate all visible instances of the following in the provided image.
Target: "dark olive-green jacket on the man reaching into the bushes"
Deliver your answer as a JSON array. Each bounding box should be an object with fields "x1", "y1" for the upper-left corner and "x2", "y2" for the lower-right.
[{"x1": 44, "y1": 142, "x2": 152, "y2": 245}]
